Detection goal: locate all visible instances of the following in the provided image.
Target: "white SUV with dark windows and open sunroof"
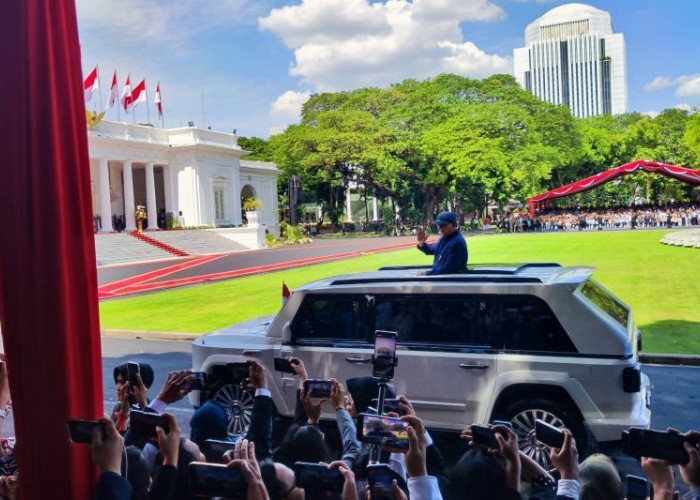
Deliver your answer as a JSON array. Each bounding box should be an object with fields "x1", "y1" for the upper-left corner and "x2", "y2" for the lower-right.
[{"x1": 191, "y1": 264, "x2": 650, "y2": 461}]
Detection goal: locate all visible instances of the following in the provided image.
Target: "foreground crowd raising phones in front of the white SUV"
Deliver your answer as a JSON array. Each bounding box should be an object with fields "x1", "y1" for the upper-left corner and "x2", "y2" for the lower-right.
[{"x1": 61, "y1": 358, "x2": 700, "y2": 500}]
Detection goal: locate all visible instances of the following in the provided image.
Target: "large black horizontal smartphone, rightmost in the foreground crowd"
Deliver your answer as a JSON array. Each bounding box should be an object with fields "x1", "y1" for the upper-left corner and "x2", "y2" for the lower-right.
[{"x1": 622, "y1": 427, "x2": 690, "y2": 464}]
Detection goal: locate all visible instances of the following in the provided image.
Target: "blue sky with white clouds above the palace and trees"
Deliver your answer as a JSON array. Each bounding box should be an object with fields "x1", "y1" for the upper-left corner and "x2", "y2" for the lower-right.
[{"x1": 76, "y1": 0, "x2": 700, "y2": 138}]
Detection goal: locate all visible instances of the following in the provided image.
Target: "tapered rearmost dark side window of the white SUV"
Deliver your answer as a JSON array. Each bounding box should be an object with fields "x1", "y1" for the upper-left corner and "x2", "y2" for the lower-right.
[{"x1": 494, "y1": 295, "x2": 576, "y2": 352}]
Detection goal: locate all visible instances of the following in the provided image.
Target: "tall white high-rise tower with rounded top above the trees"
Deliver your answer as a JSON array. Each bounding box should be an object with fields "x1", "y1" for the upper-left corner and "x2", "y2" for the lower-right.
[{"x1": 513, "y1": 3, "x2": 627, "y2": 117}]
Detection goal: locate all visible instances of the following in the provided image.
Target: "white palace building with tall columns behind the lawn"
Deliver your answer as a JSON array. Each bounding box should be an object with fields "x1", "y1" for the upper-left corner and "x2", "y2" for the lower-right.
[{"x1": 88, "y1": 120, "x2": 281, "y2": 233}]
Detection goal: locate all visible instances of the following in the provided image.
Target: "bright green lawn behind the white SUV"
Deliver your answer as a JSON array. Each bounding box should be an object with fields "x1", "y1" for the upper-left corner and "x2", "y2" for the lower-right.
[{"x1": 100, "y1": 231, "x2": 700, "y2": 354}]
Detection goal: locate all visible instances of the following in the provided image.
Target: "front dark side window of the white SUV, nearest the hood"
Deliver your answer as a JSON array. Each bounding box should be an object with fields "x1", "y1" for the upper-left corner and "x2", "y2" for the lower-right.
[{"x1": 291, "y1": 294, "x2": 366, "y2": 342}]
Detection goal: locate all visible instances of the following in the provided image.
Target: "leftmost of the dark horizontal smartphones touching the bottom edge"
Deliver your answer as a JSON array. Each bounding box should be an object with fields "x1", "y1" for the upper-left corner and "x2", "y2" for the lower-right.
[{"x1": 188, "y1": 462, "x2": 248, "y2": 499}]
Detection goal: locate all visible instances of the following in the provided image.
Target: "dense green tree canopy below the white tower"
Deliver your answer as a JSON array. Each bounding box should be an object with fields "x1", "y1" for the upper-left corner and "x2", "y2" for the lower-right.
[{"x1": 254, "y1": 75, "x2": 700, "y2": 222}]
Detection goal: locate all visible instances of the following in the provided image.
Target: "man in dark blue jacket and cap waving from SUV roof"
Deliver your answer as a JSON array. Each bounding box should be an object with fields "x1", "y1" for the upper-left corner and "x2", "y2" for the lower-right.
[{"x1": 416, "y1": 212, "x2": 469, "y2": 275}]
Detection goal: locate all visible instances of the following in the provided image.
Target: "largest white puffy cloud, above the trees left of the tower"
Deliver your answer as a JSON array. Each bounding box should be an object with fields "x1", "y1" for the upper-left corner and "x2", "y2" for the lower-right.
[{"x1": 259, "y1": 0, "x2": 512, "y2": 92}]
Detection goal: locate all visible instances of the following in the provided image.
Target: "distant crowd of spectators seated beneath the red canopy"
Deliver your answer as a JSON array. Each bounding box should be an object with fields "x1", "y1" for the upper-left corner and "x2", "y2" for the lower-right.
[{"x1": 492, "y1": 204, "x2": 700, "y2": 232}]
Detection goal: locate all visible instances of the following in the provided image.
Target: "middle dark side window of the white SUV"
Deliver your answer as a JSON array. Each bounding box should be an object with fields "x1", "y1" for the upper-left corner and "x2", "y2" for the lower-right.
[{"x1": 374, "y1": 294, "x2": 492, "y2": 346}]
